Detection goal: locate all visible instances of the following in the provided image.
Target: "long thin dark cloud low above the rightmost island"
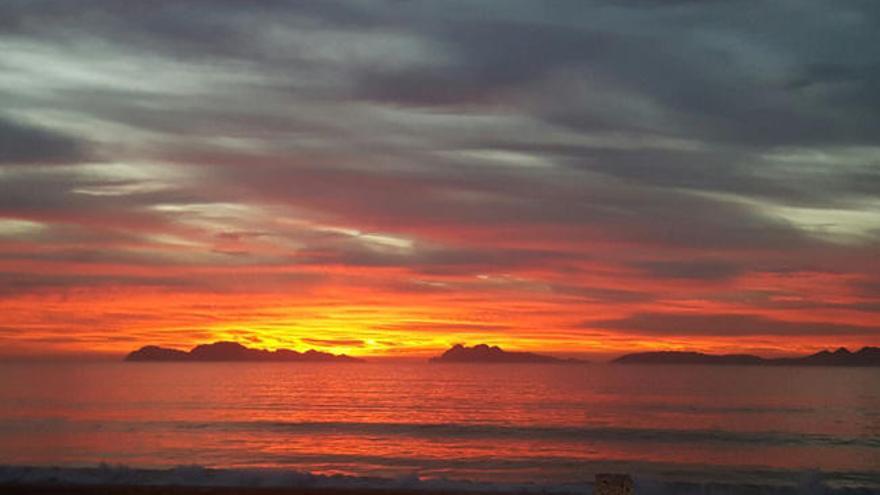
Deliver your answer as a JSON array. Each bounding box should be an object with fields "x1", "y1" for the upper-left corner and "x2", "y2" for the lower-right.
[{"x1": 584, "y1": 313, "x2": 880, "y2": 336}]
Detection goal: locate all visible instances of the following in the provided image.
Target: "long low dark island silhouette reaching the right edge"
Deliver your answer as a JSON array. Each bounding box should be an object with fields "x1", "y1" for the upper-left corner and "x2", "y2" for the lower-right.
[{"x1": 612, "y1": 347, "x2": 880, "y2": 366}]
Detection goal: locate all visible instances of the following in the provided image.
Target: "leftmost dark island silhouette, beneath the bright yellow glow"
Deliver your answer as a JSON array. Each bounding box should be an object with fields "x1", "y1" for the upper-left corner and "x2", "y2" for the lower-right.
[{"x1": 125, "y1": 342, "x2": 363, "y2": 363}]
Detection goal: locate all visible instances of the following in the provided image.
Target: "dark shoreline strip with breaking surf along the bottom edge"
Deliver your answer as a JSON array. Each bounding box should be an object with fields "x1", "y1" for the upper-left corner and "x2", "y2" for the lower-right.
[{"x1": 0, "y1": 464, "x2": 880, "y2": 495}]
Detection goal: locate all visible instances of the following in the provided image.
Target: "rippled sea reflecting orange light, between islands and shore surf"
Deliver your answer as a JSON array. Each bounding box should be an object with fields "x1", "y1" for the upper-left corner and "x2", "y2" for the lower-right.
[{"x1": 0, "y1": 363, "x2": 880, "y2": 489}]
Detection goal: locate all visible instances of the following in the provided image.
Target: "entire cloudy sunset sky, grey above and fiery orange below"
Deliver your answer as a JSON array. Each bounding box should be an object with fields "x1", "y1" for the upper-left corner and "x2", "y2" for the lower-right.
[{"x1": 0, "y1": 0, "x2": 880, "y2": 357}]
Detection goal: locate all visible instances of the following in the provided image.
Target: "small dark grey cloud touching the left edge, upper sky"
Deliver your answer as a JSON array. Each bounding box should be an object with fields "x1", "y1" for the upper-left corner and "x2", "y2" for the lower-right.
[{"x1": 0, "y1": 116, "x2": 86, "y2": 165}]
